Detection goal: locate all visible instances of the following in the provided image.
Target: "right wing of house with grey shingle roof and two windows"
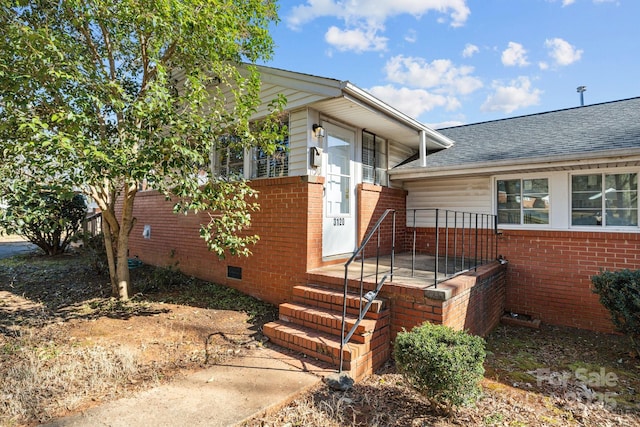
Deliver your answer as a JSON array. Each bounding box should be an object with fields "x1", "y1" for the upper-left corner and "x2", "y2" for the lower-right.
[{"x1": 389, "y1": 98, "x2": 640, "y2": 332}]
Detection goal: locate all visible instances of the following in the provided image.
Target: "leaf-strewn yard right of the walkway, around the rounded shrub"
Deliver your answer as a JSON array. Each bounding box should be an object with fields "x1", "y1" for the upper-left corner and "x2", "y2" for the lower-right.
[{"x1": 244, "y1": 326, "x2": 640, "y2": 427}]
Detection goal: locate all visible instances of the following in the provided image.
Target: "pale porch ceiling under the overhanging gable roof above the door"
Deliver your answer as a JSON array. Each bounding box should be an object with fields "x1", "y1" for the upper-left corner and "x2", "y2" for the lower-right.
[{"x1": 311, "y1": 96, "x2": 443, "y2": 150}]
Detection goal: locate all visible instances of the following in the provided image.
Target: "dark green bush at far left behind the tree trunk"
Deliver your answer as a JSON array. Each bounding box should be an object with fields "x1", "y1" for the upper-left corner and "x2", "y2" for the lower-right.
[{"x1": 0, "y1": 181, "x2": 87, "y2": 255}]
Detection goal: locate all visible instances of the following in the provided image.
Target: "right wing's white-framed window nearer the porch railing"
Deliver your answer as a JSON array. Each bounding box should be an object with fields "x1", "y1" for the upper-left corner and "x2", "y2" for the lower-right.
[{"x1": 496, "y1": 178, "x2": 550, "y2": 225}]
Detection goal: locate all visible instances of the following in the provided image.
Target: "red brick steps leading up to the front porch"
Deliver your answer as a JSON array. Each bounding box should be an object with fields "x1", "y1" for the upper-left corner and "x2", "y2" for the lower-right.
[{"x1": 263, "y1": 285, "x2": 390, "y2": 381}]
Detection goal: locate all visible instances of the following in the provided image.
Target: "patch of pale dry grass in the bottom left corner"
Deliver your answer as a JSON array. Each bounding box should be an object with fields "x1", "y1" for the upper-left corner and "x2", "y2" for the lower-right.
[{"x1": 0, "y1": 327, "x2": 141, "y2": 425}]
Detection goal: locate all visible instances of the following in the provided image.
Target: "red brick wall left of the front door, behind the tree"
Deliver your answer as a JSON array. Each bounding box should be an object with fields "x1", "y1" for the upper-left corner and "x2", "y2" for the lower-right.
[{"x1": 129, "y1": 177, "x2": 323, "y2": 304}]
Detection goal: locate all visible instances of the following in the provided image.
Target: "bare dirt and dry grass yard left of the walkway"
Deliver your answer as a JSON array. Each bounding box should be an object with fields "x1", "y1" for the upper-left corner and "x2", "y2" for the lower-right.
[{"x1": 0, "y1": 252, "x2": 275, "y2": 427}]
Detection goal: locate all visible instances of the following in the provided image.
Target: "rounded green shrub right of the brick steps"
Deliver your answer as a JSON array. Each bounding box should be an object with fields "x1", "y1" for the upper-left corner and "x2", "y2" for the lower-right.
[{"x1": 394, "y1": 322, "x2": 486, "y2": 411}]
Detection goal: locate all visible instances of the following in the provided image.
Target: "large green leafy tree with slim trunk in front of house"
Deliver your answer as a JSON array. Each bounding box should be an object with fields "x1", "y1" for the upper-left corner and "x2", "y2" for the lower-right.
[{"x1": 0, "y1": 0, "x2": 284, "y2": 299}]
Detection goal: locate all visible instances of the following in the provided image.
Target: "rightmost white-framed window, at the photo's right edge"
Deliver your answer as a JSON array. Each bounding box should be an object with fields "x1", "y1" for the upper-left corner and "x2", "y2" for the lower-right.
[{"x1": 571, "y1": 173, "x2": 638, "y2": 227}]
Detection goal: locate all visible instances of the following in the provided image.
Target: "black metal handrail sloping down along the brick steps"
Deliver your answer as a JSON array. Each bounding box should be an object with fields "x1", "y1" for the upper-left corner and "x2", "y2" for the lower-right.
[{"x1": 339, "y1": 209, "x2": 396, "y2": 372}]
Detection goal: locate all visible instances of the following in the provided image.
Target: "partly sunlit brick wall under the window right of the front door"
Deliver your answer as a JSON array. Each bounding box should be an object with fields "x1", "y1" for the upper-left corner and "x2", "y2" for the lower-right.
[{"x1": 357, "y1": 183, "x2": 407, "y2": 257}]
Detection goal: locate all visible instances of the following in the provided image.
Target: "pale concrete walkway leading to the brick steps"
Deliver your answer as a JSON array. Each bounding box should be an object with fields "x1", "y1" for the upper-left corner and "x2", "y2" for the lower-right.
[{"x1": 46, "y1": 348, "x2": 321, "y2": 427}]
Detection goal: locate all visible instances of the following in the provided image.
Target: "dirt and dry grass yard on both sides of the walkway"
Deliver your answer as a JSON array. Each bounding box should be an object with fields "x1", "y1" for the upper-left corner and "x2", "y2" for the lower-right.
[{"x1": 0, "y1": 251, "x2": 640, "y2": 426}]
